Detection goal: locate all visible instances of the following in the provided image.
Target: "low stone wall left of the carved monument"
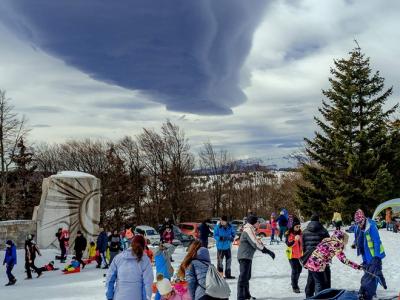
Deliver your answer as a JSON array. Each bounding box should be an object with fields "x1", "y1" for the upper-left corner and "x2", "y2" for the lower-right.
[{"x1": 0, "y1": 220, "x2": 37, "y2": 249}]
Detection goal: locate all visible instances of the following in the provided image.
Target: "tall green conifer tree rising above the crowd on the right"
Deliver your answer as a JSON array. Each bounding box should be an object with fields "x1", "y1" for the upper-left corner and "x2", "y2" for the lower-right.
[{"x1": 298, "y1": 47, "x2": 397, "y2": 219}]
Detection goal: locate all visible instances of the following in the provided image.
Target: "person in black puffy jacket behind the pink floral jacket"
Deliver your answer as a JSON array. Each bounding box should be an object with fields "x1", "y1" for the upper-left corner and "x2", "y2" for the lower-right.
[{"x1": 303, "y1": 214, "x2": 331, "y2": 298}]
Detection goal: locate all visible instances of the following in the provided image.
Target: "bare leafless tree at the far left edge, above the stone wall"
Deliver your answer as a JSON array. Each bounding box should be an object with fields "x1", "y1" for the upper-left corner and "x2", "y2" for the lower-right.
[{"x1": 0, "y1": 90, "x2": 29, "y2": 206}]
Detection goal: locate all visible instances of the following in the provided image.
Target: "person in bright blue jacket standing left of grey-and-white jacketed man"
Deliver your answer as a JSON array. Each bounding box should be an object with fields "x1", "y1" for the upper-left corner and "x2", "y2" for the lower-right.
[{"x1": 214, "y1": 216, "x2": 235, "y2": 279}]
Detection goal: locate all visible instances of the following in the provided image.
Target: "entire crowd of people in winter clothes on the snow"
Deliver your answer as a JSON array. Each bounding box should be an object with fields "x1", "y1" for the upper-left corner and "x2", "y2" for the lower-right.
[{"x1": 3, "y1": 210, "x2": 386, "y2": 300}]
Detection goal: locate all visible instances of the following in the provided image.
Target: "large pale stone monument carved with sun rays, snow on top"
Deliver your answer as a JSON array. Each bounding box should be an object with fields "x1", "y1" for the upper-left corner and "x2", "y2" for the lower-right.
[{"x1": 36, "y1": 171, "x2": 101, "y2": 248}]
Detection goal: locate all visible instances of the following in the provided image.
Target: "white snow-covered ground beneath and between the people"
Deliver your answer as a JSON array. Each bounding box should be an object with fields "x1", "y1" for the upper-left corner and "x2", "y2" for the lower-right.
[{"x1": 0, "y1": 230, "x2": 400, "y2": 300}]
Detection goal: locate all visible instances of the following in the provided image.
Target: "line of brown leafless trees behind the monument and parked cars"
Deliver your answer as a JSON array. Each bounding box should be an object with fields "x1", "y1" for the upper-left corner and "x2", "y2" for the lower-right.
[{"x1": 0, "y1": 92, "x2": 300, "y2": 226}]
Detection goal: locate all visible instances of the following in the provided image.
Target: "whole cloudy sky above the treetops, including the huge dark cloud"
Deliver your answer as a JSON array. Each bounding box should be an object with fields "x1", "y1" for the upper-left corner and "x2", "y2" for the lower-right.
[{"x1": 0, "y1": 0, "x2": 400, "y2": 165}]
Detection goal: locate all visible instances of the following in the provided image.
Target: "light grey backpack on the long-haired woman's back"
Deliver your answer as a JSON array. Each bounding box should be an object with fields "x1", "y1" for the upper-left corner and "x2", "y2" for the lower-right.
[{"x1": 201, "y1": 262, "x2": 231, "y2": 299}]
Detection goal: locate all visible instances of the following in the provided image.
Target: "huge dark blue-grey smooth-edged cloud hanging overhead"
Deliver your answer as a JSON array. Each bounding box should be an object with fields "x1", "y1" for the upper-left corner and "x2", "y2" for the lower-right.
[{"x1": 0, "y1": 0, "x2": 267, "y2": 114}]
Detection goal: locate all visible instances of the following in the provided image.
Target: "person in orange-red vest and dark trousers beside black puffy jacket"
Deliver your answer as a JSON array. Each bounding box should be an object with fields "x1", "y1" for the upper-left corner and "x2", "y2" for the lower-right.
[{"x1": 285, "y1": 217, "x2": 303, "y2": 293}]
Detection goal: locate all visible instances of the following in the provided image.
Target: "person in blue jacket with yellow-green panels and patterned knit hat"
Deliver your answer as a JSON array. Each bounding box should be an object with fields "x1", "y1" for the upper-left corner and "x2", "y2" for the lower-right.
[{"x1": 354, "y1": 209, "x2": 386, "y2": 300}]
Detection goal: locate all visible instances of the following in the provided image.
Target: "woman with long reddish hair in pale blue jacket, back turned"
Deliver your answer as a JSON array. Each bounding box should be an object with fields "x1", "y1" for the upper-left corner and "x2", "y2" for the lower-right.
[{"x1": 106, "y1": 236, "x2": 154, "y2": 300}]
